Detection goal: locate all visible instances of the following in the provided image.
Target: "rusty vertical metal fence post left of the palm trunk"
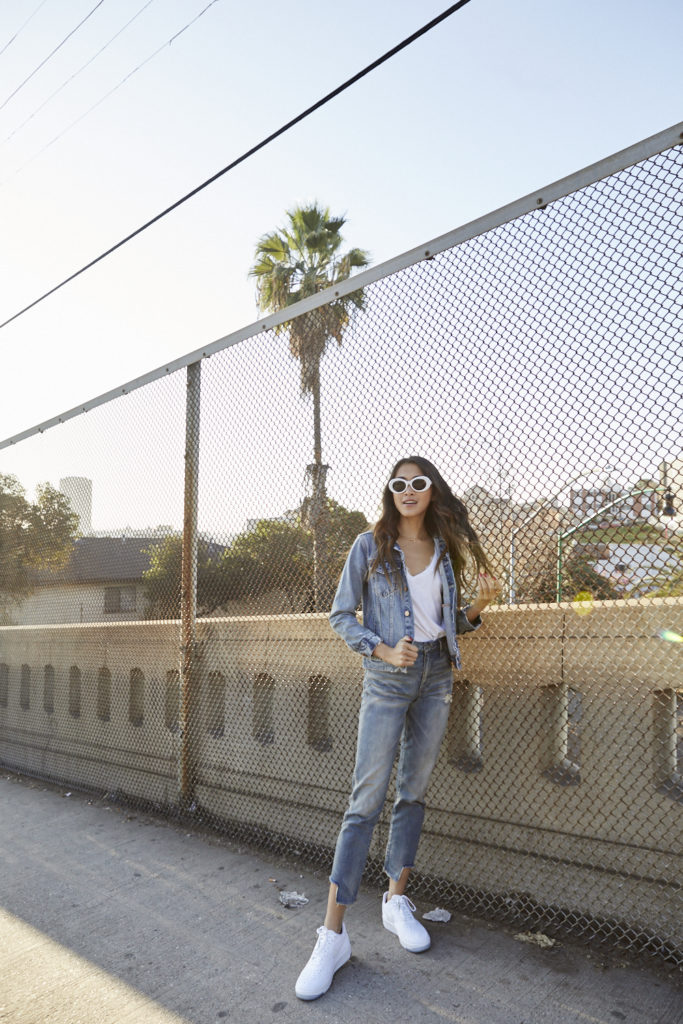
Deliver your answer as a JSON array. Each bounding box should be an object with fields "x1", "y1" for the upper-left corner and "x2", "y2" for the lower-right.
[{"x1": 178, "y1": 361, "x2": 202, "y2": 808}]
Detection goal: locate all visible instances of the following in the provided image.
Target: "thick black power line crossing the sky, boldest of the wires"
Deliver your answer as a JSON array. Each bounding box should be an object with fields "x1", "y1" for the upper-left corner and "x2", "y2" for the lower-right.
[{"x1": 0, "y1": 0, "x2": 470, "y2": 330}]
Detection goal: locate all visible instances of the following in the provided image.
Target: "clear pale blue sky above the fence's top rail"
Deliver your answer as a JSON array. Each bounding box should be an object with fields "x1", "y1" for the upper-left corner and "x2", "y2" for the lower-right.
[{"x1": 0, "y1": 0, "x2": 683, "y2": 536}]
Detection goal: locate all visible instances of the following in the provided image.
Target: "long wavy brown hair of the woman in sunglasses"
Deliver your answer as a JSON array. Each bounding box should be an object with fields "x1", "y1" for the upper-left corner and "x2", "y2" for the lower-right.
[{"x1": 371, "y1": 456, "x2": 490, "y2": 594}]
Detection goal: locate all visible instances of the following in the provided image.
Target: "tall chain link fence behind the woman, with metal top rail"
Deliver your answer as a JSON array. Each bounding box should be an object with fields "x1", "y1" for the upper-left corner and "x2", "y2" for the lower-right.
[{"x1": 0, "y1": 126, "x2": 683, "y2": 965}]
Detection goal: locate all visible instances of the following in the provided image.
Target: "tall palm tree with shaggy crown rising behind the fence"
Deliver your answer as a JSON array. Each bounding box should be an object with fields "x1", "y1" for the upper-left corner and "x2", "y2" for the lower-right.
[{"x1": 249, "y1": 203, "x2": 370, "y2": 609}]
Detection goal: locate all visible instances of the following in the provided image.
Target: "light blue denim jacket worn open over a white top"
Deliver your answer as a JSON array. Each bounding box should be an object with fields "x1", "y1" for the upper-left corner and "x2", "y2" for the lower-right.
[{"x1": 330, "y1": 531, "x2": 481, "y2": 672}]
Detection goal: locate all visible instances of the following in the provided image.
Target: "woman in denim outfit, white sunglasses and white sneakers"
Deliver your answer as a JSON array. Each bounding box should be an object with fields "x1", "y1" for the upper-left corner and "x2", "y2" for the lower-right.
[{"x1": 296, "y1": 457, "x2": 500, "y2": 999}]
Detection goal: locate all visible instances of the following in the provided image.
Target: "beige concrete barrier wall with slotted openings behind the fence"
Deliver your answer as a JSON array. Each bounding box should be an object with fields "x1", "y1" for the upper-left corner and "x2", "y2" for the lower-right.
[{"x1": 0, "y1": 598, "x2": 683, "y2": 948}]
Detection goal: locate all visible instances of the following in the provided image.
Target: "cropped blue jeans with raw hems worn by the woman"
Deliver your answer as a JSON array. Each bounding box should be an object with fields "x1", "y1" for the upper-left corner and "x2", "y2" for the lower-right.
[{"x1": 330, "y1": 639, "x2": 453, "y2": 905}]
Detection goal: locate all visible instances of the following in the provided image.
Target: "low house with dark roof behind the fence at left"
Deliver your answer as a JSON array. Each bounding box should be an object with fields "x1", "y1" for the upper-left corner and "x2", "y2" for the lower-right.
[{"x1": 11, "y1": 537, "x2": 160, "y2": 626}]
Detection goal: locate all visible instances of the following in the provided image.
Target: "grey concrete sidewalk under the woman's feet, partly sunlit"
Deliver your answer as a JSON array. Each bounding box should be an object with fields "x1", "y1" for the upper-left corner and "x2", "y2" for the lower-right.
[{"x1": 0, "y1": 772, "x2": 683, "y2": 1024}]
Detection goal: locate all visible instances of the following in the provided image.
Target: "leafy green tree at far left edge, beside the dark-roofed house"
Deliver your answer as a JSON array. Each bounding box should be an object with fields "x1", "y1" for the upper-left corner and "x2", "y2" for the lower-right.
[{"x1": 0, "y1": 473, "x2": 78, "y2": 620}]
